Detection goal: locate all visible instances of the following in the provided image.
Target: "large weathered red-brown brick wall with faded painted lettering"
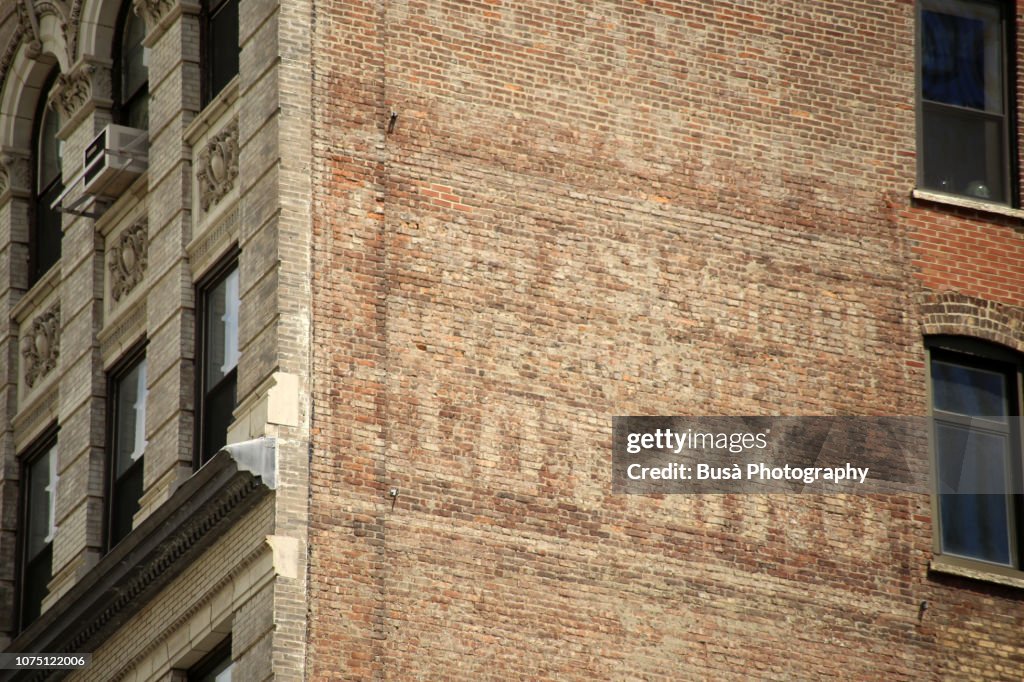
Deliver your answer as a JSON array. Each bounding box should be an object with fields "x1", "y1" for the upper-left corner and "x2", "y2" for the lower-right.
[{"x1": 309, "y1": 0, "x2": 1024, "y2": 679}]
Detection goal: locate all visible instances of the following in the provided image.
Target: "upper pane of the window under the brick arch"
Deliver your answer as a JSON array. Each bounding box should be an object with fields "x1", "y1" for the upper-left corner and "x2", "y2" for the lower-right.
[{"x1": 932, "y1": 360, "x2": 1008, "y2": 421}]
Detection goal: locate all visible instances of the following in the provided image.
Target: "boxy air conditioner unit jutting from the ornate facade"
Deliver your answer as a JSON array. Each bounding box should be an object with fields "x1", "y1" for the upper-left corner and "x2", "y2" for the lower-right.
[{"x1": 82, "y1": 124, "x2": 150, "y2": 197}]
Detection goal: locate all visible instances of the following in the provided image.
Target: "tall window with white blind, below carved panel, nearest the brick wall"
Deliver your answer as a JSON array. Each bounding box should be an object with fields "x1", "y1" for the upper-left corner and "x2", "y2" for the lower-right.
[{"x1": 197, "y1": 261, "x2": 239, "y2": 466}]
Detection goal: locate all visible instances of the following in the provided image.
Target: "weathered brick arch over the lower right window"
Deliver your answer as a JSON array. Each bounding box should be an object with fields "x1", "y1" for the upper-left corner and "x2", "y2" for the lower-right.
[{"x1": 919, "y1": 292, "x2": 1024, "y2": 353}]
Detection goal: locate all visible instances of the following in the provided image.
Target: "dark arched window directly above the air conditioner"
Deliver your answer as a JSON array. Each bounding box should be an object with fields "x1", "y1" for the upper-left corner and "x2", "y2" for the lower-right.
[{"x1": 114, "y1": 2, "x2": 150, "y2": 130}]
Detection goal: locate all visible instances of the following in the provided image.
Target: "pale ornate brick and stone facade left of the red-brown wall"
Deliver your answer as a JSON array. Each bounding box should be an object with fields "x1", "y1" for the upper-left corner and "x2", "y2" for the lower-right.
[{"x1": 0, "y1": 0, "x2": 311, "y2": 680}]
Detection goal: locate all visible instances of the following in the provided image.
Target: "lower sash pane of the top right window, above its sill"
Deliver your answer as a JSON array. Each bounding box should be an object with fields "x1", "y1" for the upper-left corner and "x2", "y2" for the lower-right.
[{"x1": 921, "y1": 103, "x2": 1009, "y2": 203}]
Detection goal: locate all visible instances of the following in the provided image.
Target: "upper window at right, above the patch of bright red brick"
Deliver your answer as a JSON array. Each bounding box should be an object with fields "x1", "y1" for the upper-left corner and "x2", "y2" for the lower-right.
[{"x1": 918, "y1": 0, "x2": 1014, "y2": 204}]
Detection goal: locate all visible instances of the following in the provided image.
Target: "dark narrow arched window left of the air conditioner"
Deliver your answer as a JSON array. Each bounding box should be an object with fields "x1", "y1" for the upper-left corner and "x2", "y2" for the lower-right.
[{"x1": 29, "y1": 71, "x2": 63, "y2": 286}]
